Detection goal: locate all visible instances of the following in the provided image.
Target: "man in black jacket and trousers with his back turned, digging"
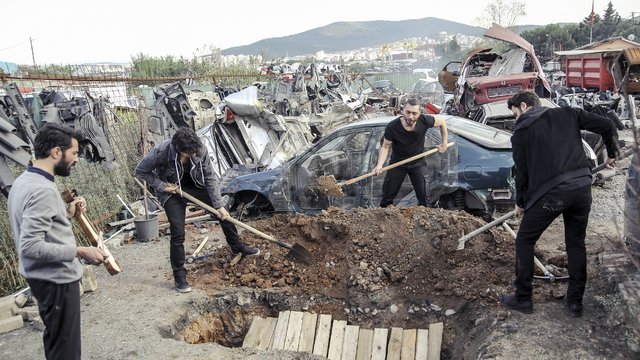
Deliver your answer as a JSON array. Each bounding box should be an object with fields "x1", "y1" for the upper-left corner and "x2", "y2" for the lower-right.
[{"x1": 500, "y1": 92, "x2": 618, "y2": 317}]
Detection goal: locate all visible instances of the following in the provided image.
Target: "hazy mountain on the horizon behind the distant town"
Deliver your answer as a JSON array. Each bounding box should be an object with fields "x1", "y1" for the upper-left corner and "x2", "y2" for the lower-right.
[{"x1": 222, "y1": 17, "x2": 486, "y2": 58}]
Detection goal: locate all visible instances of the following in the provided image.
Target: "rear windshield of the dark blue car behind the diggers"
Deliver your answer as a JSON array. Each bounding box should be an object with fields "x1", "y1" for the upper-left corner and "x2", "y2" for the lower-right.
[{"x1": 447, "y1": 117, "x2": 511, "y2": 150}]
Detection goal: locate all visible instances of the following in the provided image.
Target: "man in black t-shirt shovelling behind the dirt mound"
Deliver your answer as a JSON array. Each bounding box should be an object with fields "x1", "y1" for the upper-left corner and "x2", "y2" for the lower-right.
[{"x1": 373, "y1": 98, "x2": 447, "y2": 207}]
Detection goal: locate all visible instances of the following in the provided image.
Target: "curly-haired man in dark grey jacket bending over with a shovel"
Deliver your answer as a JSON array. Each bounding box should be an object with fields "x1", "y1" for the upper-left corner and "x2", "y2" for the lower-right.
[{"x1": 135, "y1": 127, "x2": 260, "y2": 293}]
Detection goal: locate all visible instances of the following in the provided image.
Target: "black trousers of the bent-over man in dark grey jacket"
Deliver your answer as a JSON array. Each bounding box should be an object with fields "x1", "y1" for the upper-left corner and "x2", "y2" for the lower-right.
[{"x1": 164, "y1": 188, "x2": 240, "y2": 279}]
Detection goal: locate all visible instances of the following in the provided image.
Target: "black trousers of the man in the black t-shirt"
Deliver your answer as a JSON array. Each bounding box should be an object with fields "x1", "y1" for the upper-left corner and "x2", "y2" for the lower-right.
[{"x1": 380, "y1": 163, "x2": 427, "y2": 207}]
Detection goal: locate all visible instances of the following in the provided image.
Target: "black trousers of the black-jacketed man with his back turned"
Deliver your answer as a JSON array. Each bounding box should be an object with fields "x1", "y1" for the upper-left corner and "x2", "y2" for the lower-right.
[{"x1": 515, "y1": 185, "x2": 591, "y2": 303}]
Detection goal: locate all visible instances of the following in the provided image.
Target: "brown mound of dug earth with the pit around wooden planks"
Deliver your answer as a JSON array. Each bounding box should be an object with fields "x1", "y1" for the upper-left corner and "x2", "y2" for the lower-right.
[{"x1": 165, "y1": 207, "x2": 568, "y2": 359}]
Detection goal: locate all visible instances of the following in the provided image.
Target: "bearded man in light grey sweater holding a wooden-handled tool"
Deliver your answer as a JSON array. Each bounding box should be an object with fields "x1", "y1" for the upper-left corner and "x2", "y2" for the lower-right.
[{"x1": 8, "y1": 124, "x2": 107, "y2": 359}]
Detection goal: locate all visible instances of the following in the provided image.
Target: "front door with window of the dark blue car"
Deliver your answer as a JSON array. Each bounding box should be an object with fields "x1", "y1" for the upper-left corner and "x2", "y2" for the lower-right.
[{"x1": 289, "y1": 128, "x2": 372, "y2": 212}]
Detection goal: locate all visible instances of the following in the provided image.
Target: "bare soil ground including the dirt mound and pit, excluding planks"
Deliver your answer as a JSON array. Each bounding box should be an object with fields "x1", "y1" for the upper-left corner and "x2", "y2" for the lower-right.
[{"x1": 0, "y1": 171, "x2": 640, "y2": 359}]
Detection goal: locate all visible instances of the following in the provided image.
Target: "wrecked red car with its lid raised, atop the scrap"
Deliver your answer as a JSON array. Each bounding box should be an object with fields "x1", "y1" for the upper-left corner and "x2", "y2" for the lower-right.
[{"x1": 438, "y1": 24, "x2": 551, "y2": 117}]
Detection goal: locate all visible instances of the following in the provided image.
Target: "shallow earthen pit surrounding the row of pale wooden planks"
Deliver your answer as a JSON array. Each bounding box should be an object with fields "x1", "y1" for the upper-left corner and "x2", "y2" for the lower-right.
[{"x1": 171, "y1": 290, "x2": 500, "y2": 359}]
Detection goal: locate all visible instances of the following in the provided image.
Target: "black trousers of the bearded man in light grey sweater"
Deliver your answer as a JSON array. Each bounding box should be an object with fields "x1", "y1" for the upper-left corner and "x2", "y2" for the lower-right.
[{"x1": 27, "y1": 279, "x2": 82, "y2": 360}]
